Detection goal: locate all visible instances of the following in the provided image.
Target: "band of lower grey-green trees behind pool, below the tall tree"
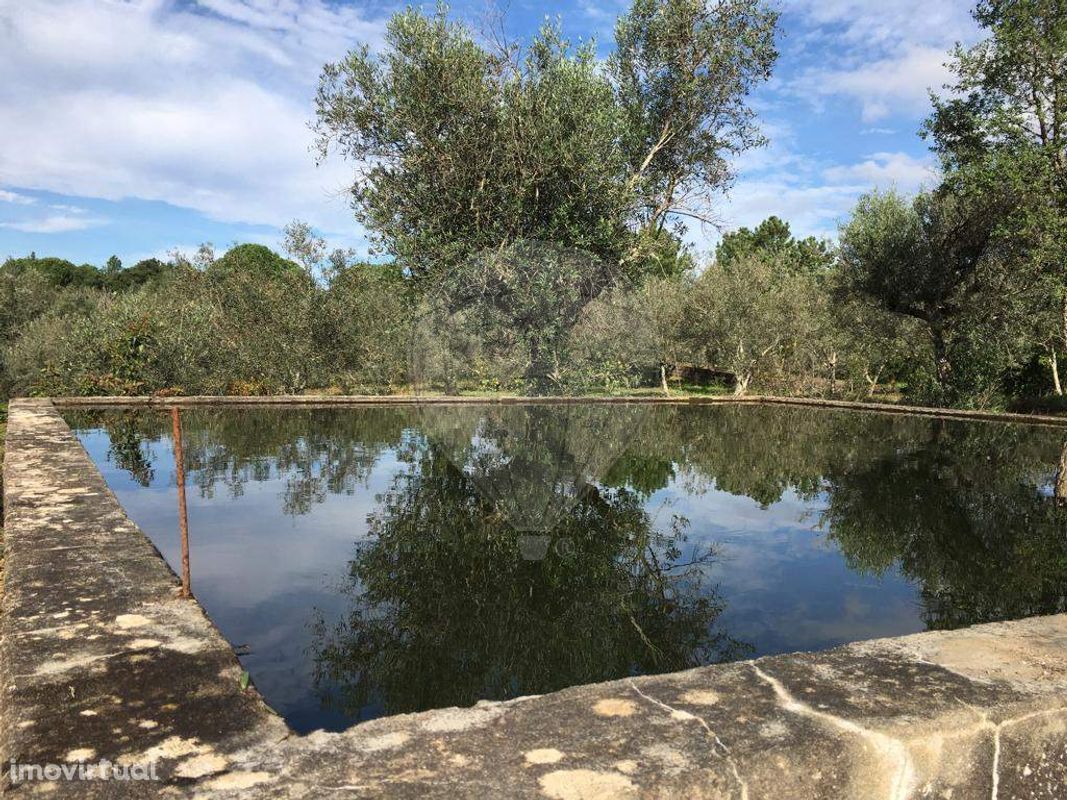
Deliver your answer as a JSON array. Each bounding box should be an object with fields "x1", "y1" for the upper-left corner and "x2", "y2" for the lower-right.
[{"x1": 0, "y1": 210, "x2": 1054, "y2": 405}]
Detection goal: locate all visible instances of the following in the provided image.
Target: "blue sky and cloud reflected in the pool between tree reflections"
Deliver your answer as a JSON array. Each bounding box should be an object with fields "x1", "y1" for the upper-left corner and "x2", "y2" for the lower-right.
[{"x1": 70, "y1": 411, "x2": 1062, "y2": 731}]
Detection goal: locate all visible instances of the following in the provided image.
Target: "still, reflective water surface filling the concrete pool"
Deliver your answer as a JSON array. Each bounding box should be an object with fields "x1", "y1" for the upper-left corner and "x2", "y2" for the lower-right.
[{"x1": 66, "y1": 404, "x2": 1067, "y2": 732}]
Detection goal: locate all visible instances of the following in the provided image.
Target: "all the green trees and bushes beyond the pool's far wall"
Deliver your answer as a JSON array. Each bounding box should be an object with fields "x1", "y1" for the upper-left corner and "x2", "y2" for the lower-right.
[{"x1": 8, "y1": 0, "x2": 1067, "y2": 406}]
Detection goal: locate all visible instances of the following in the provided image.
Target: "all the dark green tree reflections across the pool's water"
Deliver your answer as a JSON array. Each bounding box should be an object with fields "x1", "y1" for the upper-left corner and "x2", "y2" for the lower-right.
[{"x1": 71, "y1": 405, "x2": 1067, "y2": 678}]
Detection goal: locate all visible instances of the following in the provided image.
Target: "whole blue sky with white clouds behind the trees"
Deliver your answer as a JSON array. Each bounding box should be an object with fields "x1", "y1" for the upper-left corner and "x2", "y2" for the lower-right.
[{"x1": 0, "y1": 0, "x2": 978, "y2": 269}]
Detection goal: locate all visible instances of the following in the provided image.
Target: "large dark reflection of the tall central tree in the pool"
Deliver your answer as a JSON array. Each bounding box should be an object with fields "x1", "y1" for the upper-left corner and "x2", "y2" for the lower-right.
[{"x1": 316, "y1": 445, "x2": 739, "y2": 716}]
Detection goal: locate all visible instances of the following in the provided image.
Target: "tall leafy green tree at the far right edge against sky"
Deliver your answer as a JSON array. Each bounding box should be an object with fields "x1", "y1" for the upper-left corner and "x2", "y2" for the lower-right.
[{"x1": 924, "y1": 0, "x2": 1067, "y2": 393}]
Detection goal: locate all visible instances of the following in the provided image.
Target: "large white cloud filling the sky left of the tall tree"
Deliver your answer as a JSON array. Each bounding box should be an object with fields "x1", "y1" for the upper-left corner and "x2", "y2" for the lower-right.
[{"x1": 0, "y1": 0, "x2": 383, "y2": 231}]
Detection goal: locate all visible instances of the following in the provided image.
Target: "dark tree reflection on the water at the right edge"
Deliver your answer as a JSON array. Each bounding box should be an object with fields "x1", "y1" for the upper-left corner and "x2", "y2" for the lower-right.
[{"x1": 825, "y1": 420, "x2": 1067, "y2": 628}]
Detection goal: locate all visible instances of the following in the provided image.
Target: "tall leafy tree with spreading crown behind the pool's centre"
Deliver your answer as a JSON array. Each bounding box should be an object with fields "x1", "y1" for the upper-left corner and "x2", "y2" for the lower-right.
[{"x1": 317, "y1": 0, "x2": 776, "y2": 389}]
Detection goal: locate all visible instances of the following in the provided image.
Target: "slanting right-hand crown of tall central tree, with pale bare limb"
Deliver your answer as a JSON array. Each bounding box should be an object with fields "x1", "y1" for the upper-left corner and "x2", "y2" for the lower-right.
[{"x1": 608, "y1": 0, "x2": 778, "y2": 244}]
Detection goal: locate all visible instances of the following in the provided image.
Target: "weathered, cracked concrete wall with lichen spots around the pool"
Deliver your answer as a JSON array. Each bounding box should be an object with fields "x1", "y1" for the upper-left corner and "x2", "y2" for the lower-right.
[{"x1": 0, "y1": 397, "x2": 1067, "y2": 800}]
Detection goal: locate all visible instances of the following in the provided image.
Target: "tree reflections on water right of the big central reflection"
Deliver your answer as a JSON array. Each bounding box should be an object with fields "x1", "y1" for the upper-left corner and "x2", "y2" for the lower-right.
[{"x1": 609, "y1": 406, "x2": 1067, "y2": 628}]
